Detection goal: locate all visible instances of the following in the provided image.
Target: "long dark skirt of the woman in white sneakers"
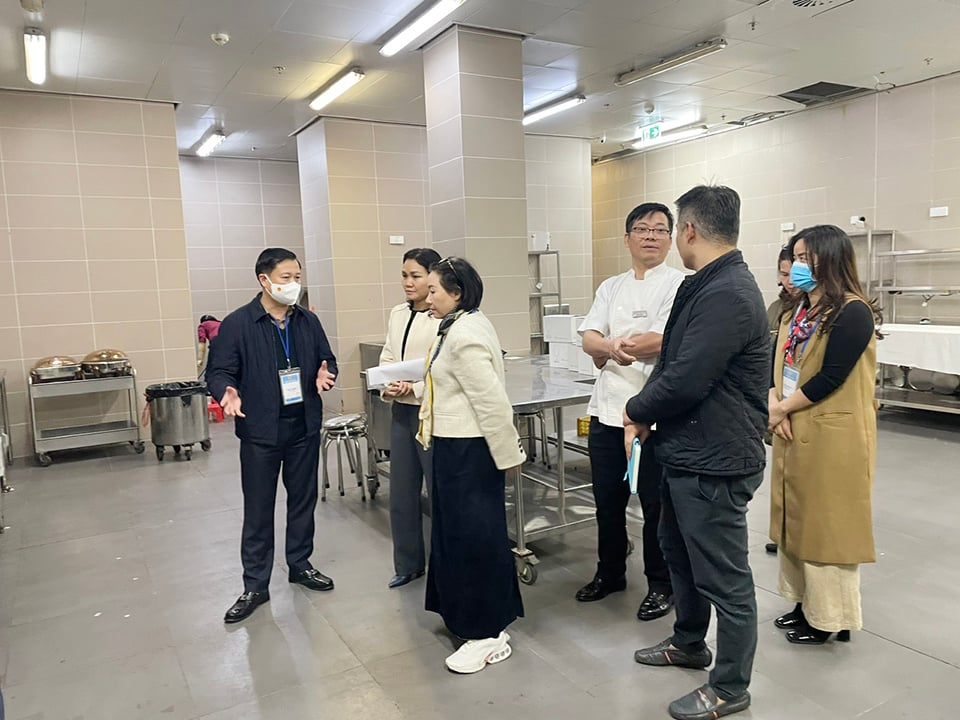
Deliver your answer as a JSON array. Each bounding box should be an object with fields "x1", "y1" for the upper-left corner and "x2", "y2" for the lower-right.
[{"x1": 426, "y1": 438, "x2": 523, "y2": 640}]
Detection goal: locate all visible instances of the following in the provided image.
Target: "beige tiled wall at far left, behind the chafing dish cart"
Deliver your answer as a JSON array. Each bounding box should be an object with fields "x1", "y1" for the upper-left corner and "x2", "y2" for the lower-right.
[{"x1": 0, "y1": 92, "x2": 196, "y2": 455}]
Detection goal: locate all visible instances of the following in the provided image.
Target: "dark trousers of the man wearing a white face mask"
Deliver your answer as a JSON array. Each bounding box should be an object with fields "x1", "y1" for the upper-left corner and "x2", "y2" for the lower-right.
[{"x1": 240, "y1": 418, "x2": 320, "y2": 592}]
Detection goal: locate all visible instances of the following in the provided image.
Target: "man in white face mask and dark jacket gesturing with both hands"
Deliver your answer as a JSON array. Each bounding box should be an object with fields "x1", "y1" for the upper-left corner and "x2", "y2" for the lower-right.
[{"x1": 207, "y1": 248, "x2": 337, "y2": 623}]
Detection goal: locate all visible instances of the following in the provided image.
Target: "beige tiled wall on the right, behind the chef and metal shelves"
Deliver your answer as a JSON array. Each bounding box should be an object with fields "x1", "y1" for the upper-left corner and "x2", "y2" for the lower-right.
[{"x1": 593, "y1": 76, "x2": 960, "y2": 323}]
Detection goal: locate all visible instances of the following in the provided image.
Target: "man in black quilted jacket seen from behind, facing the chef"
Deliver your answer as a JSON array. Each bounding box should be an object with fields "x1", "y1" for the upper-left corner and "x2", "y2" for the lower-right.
[{"x1": 624, "y1": 186, "x2": 770, "y2": 720}]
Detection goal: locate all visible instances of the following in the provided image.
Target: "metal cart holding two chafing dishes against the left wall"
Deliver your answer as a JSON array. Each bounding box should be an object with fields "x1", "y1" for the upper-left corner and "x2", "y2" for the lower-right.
[{"x1": 28, "y1": 374, "x2": 144, "y2": 467}]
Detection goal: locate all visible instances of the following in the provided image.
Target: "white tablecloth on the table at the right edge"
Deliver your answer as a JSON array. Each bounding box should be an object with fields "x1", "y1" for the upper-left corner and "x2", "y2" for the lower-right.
[{"x1": 877, "y1": 324, "x2": 960, "y2": 374}]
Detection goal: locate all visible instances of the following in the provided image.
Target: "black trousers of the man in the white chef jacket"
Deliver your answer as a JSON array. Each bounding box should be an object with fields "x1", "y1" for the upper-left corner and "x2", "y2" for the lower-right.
[{"x1": 587, "y1": 417, "x2": 670, "y2": 594}]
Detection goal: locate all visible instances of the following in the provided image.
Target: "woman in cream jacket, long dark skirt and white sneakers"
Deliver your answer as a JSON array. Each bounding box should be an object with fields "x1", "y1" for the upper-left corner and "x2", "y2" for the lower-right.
[{"x1": 419, "y1": 258, "x2": 525, "y2": 673}]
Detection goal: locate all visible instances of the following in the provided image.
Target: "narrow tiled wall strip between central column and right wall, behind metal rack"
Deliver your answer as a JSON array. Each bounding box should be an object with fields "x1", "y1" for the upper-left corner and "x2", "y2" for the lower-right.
[{"x1": 525, "y1": 135, "x2": 593, "y2": 318}]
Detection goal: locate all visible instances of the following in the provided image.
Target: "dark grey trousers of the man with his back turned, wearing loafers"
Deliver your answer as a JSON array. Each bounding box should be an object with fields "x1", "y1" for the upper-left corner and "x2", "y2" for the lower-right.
[{"x1": 660, "y1": 468, "x2": 763, "y2": 700}]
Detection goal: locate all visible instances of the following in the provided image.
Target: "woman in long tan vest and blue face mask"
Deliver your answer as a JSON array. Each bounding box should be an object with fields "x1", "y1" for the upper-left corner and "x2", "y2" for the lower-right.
[{"x1": 770, "y1": 225, "x2": 880, "y2": 645}]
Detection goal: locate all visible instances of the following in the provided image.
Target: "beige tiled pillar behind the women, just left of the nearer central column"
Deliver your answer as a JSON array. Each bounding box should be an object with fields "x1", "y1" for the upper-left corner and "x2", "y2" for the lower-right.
[{"x1": 298, "y1": 119, "x2": 432, "y2": 411}]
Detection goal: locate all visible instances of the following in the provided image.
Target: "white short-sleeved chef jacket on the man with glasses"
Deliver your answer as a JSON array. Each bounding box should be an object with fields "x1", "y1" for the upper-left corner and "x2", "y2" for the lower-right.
[{"x1": 577, "y1": 263, "x2": 686, "y2": 427}]
